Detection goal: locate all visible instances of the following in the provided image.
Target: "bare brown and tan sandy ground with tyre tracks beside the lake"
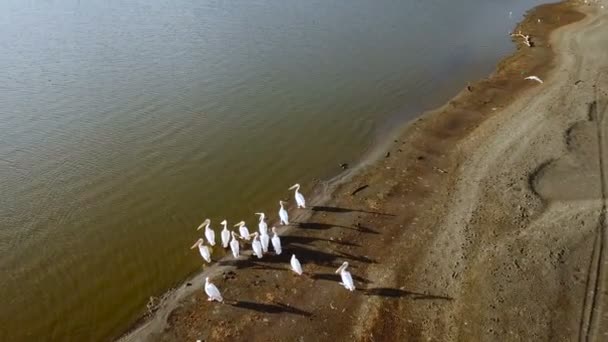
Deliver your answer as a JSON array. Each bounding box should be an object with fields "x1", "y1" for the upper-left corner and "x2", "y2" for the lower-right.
[{"x1": 123, "y1": 2, "x2": 608, "y2": 341}]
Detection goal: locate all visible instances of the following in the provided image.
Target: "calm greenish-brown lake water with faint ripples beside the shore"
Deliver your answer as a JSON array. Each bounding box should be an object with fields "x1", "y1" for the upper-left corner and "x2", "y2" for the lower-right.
[{"x1": 0, "y1": 0, "x2": 541, "y2": 341}]
